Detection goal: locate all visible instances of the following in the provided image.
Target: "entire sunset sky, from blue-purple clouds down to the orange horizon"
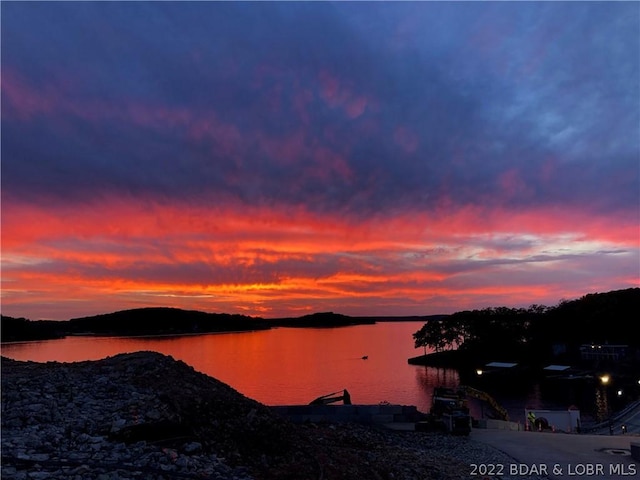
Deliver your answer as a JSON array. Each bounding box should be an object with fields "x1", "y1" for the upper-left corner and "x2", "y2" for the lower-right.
[{"x1": 1, "y1": 2, "x2": 640, "y2": 319}]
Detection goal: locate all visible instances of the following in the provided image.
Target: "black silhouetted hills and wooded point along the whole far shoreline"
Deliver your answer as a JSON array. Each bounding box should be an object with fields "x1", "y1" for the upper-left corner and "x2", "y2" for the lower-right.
[{"x1": 0, "y1": 288, "x2": 640, "y2": 352}]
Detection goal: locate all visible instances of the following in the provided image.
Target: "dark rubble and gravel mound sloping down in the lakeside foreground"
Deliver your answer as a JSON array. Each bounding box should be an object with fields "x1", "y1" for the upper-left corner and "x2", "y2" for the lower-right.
[{"x1": 0, "y1": 352, "x2": 548, "y2": 480}]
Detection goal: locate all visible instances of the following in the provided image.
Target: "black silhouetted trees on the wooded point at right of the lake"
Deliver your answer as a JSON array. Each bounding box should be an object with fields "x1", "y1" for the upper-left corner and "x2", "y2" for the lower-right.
[{"x1": 413, "y1": 288, "x2": 640, "y2": 368}]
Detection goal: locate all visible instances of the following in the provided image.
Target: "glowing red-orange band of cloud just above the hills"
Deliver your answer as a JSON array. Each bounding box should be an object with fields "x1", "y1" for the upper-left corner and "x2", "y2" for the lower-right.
[{"x1": 2, "y1": 199, "x2": 638, "y2": 318}]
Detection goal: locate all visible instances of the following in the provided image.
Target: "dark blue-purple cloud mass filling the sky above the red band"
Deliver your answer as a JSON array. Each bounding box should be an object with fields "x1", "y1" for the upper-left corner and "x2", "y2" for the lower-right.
[{"x1": 2, "y1": 2, "x2": 640, "y2": 218}]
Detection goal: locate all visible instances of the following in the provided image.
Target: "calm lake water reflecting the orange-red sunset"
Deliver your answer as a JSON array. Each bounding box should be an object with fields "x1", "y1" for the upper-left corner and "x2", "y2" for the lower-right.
[{"x1": 1, "y1": 322, "x2": 596, "y2": 420}]
